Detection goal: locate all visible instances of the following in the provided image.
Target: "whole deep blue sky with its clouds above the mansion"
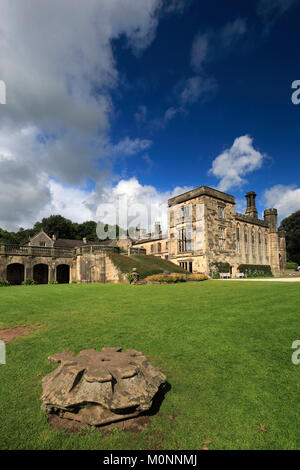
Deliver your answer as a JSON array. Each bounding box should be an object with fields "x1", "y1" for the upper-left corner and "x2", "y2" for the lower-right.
[{"x1": 0, "y1": 0, "x2": 300, "y2": 228}]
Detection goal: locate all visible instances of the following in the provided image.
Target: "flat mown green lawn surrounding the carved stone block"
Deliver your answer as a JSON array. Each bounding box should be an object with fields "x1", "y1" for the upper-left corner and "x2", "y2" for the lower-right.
[{"x1": 0, "y1": 281, "x2": 300, "y2": 449}]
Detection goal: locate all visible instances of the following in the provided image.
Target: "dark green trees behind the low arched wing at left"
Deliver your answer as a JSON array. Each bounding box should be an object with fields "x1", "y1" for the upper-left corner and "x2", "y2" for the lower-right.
[{"x1": 0, "y1": 215, "x2": 119, "y2": 245}]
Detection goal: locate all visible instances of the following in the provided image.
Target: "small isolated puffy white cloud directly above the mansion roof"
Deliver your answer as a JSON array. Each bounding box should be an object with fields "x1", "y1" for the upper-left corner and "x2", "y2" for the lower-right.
[{"x1": 209, "y1": 135, "x2": 265, "y2": 191}]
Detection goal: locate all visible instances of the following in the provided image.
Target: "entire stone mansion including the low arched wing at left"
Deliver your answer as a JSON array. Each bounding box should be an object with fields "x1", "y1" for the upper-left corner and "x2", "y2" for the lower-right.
[{"x1": 0, "y1": 186, "x2": 286, "y2": 284}]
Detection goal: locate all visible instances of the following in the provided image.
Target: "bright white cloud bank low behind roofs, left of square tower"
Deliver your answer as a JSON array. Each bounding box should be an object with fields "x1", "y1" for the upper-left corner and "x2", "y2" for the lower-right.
[{"x1": 38, "y1": 178, "x2": 191, "y2": 237}]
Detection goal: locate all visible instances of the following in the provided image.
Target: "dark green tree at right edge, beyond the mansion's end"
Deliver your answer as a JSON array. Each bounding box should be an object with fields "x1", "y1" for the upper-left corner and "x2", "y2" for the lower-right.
[{"x1": 280, "y1": 211, "x2": 300, "y2": 265}]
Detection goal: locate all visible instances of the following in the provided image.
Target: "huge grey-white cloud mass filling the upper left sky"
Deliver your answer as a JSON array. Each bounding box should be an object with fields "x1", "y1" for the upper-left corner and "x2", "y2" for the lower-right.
[{"x1": 0, "y1": 0, "x2": 173, "y2": 228}]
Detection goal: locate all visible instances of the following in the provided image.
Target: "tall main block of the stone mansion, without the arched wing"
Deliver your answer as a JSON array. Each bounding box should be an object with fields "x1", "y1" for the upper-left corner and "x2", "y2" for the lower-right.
[{"x1": 135, "y1": 186, "x2": 286, "y2": 276}]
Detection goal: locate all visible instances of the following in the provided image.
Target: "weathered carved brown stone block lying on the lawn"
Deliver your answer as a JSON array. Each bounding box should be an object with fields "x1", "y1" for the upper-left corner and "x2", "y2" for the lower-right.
[{"x1": 41, "y1": 348, "x2": 166, "y2": 426}]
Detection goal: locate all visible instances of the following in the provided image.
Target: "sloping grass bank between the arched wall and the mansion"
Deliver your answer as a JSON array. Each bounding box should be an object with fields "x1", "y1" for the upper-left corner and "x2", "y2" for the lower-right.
[{"x1": 109, "y1": 253, "x2": 186, "y2": 279}]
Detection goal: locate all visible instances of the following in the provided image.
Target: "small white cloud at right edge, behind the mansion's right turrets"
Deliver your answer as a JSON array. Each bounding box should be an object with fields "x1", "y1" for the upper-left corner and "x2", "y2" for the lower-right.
[{"x1": 264, "y1": 184, "x2": 300, "y2": 218}]
